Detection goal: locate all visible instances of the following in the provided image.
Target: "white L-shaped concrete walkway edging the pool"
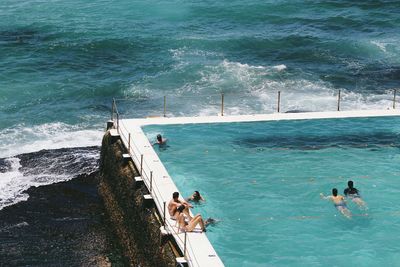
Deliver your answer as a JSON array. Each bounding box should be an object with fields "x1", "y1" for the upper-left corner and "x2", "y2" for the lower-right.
[{"x1": 117, "y1": 109, "x2": 400, "y2": 267}]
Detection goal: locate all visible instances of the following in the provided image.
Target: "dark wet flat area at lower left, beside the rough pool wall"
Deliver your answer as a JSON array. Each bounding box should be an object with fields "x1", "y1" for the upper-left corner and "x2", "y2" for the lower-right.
[{"x1": 0, "y1": 172, "x2": 126, "y2": 266}]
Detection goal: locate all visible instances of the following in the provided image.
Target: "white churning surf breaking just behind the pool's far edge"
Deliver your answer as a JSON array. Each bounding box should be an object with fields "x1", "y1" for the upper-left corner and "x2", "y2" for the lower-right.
[{"x1": 123, "y1": 55, "x2": 392, "y2": 116}]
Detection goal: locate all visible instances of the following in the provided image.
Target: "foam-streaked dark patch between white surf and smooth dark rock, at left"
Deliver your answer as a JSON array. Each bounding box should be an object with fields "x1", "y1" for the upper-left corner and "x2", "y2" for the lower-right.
[{"x1": 0, "y1": 147, "x2": 99, "y2": 210}]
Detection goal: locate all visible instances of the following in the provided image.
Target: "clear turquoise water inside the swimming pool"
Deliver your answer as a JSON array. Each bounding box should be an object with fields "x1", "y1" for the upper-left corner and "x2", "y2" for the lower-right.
[{"x1": 144, "y1": 117, "x2": 400, "y2": 266}]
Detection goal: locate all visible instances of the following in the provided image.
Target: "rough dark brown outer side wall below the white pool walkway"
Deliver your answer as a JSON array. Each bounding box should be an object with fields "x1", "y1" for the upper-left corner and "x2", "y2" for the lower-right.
[{"x1": 99, "y1": 132, "x2": 178, "y2": 266}]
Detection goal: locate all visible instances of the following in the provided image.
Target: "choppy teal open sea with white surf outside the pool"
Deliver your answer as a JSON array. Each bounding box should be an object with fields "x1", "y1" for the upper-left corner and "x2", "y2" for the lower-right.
[{"x1": 0, "y1": 0, "x2": 400, "y2": 266}]
